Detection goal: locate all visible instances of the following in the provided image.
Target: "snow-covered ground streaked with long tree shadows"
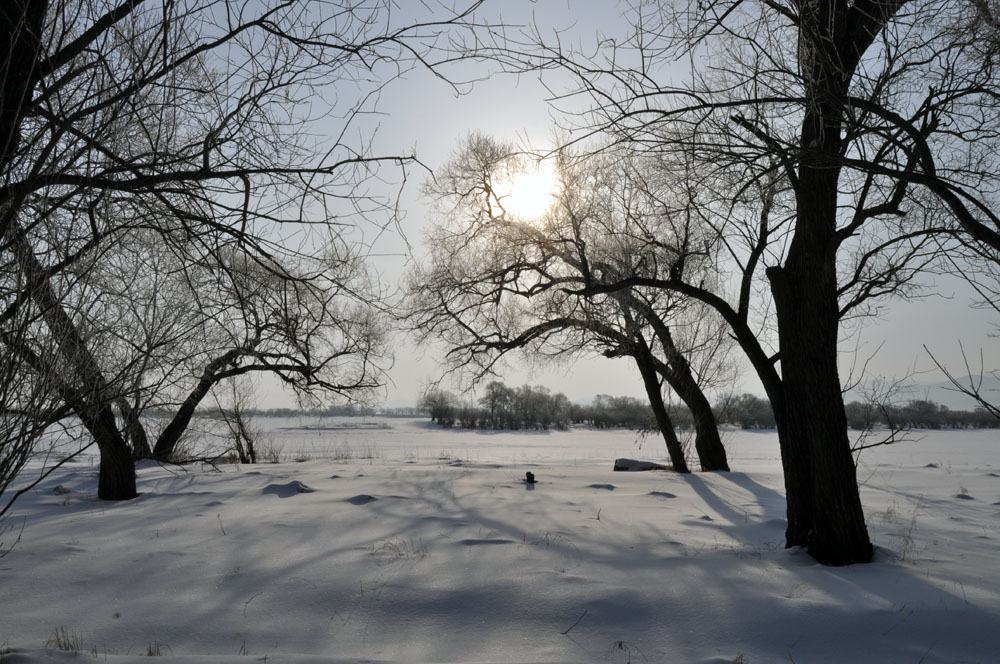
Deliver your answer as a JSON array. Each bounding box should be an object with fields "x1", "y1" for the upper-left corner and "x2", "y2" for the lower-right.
[{"x1": 0, "y1": 419, "x2": 1000, "y2": 664}]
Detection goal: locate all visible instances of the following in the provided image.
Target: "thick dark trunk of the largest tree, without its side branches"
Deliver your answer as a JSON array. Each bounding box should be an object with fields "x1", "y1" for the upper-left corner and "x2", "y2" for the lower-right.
[{"x1": 752, "y1": 0, "x2": 876, "y2": 565}]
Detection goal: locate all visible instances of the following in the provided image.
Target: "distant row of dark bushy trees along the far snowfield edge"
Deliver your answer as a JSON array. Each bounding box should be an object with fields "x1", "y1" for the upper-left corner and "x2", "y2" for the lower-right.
[{"x1": 417, "y1": 381, "x2": 1000, "y2": 430}]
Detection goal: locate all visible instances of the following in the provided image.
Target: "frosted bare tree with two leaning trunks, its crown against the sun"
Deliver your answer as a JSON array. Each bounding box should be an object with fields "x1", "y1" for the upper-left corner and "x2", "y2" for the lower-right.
[{"x1": 410, "y1": 135, "x2": 728, "y2": 471}]
